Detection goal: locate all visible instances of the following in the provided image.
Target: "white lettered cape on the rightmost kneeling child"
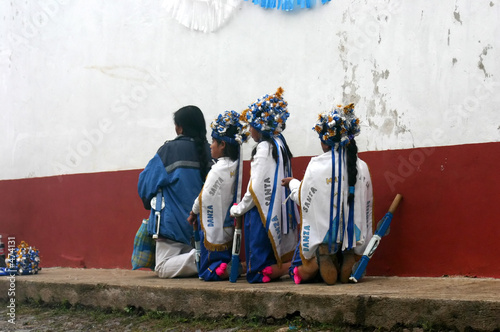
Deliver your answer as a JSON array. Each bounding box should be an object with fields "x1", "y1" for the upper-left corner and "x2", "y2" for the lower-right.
[{"x1": 299, "y1": 151, "x2": 373, "y2": 260}]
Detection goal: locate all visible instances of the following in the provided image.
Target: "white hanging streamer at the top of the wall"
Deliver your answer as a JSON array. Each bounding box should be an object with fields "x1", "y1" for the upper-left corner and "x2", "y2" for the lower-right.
[{"x1": 163, "y1": 0, "x2": 241, "y2": 32}]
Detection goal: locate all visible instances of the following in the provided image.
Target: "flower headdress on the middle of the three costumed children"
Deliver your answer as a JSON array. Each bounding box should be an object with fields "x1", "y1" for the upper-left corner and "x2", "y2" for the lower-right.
[{"x1": 241, "y1": 87, "x2": 290, "y2": 137}]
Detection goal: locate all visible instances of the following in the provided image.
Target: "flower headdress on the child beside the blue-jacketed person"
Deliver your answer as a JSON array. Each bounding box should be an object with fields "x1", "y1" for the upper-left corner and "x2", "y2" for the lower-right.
[{"x1": 210, "y1": 111, "x2": 250, "y2": 145}]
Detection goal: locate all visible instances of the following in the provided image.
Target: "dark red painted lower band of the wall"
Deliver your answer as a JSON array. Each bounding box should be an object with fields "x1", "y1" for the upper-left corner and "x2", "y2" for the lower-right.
[{"x1": 0, "y1": 143, "x2": 500, "y2": 278}]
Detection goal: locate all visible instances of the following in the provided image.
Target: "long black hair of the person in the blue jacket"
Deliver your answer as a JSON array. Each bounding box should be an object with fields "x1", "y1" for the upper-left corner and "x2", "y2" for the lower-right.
[{"x1": 174, "y1": 105, "x2": 209, "y2": 182}]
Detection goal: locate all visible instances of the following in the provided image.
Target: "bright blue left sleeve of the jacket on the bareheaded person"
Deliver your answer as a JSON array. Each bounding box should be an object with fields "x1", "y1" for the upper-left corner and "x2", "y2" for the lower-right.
[{"x1": 137, "y1": 154, "x2": 169, "y2": 210}]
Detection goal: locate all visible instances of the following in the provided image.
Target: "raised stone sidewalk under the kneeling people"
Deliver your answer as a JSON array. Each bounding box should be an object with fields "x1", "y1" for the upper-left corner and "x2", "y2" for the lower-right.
[{"x1": 0, "y1": 268, "x2": 500, "y2": 331}]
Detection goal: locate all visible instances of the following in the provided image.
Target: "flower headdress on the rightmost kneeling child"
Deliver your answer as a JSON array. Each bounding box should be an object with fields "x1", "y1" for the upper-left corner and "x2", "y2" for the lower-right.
[{"x1": 313, "y1": 104, "x2": 360, "y2": 146}]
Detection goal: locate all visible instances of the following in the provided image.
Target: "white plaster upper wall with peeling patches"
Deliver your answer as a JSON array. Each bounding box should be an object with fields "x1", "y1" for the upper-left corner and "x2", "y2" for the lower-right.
[{"x1": 0, "y1": 0, "x2": 500, "y2": 179}]
